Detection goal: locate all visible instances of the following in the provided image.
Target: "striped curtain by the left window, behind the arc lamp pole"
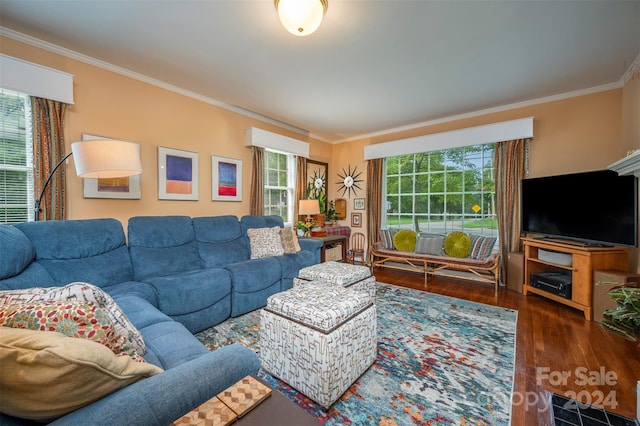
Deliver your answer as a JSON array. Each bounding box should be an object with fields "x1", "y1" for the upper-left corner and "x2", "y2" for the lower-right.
[{"x1": 31, "y1": 96, "x2": 68, "y2": 220}]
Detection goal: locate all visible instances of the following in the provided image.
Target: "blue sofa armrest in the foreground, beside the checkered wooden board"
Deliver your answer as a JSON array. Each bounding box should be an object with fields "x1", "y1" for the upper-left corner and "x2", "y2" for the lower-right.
[{"x1": 51, "y1": 344, "x2": 260, "y2": 426}]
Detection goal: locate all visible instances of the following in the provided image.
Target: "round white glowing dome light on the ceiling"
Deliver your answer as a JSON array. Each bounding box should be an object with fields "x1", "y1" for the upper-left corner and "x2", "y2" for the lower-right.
[{"x1": 274, "y1": 0, "x2": 329, "y2": 36}]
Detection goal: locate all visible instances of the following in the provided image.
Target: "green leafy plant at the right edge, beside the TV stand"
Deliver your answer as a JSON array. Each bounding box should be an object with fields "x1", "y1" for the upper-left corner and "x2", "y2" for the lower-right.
[{"x1": 602, "y1": 283, "x2": 640, "y2": 341}]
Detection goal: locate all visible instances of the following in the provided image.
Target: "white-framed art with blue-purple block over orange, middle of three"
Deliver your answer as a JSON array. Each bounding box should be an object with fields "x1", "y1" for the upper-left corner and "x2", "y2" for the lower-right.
[{"x1": 158, "y1": 146, "x2": 198, "y2": 200}]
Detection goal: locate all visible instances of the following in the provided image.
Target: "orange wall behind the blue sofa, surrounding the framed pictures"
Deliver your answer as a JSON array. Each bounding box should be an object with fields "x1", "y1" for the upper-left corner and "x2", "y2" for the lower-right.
[{"x1": 0, "y1": 38, "x2": 330, "y2": 226}]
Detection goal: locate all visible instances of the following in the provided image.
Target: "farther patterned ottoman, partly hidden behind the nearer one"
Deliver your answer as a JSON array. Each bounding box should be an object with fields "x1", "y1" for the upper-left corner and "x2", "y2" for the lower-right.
[{"x1": 293, "y1": 262, "x2": 376, "y2": 302}]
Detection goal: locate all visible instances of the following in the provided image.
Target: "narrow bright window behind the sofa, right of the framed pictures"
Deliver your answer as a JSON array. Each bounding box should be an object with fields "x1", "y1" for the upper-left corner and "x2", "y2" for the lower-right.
[{"x1": 264, "y1": 149, "x2": 295, "y2": 226}]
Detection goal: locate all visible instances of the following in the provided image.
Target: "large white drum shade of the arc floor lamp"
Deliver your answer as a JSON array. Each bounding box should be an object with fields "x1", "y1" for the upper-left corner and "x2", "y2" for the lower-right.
[{"x1": 71, "y1": 139, "x2": 142, "y2": 178}]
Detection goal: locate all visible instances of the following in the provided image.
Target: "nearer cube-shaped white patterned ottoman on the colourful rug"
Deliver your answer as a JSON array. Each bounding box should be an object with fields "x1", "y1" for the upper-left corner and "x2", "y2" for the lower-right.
[{"x1": 260, "y1": 283, "x2": 377, "y2": 408}]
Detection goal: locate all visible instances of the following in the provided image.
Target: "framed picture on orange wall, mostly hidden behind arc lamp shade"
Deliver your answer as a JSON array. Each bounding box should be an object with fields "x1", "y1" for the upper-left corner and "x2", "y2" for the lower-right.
[{"x1": 82, "y1": 133, "x2": 140, "y2": 200}]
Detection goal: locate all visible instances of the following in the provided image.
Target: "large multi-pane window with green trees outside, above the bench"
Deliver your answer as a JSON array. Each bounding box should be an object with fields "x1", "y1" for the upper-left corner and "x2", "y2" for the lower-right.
[{"x1": 382, "y1": 144, "x2": 498, "y2": 237}]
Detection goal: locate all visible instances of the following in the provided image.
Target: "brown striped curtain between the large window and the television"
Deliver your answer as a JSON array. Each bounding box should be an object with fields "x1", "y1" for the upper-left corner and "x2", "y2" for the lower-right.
[{"x1": 494, "y1": 139, "x2": 530, "y2": 279}]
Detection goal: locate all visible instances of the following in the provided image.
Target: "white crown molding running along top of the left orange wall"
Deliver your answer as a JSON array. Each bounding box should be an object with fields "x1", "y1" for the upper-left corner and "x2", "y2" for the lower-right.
[{"x1": 0, "y1": 26, "x2": 309, "y2": 137}]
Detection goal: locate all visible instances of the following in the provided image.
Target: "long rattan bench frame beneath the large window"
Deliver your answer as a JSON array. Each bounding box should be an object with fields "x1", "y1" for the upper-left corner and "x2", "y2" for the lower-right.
[{"x1": 370, "y1": 241, "x2": 500, "y2": 291}]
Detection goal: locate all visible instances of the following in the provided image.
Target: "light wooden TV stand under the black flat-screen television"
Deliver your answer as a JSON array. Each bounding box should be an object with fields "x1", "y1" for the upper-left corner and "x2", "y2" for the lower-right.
[{"x1": 522, "y1": 238, "x2": 629, "y2": 321}]
